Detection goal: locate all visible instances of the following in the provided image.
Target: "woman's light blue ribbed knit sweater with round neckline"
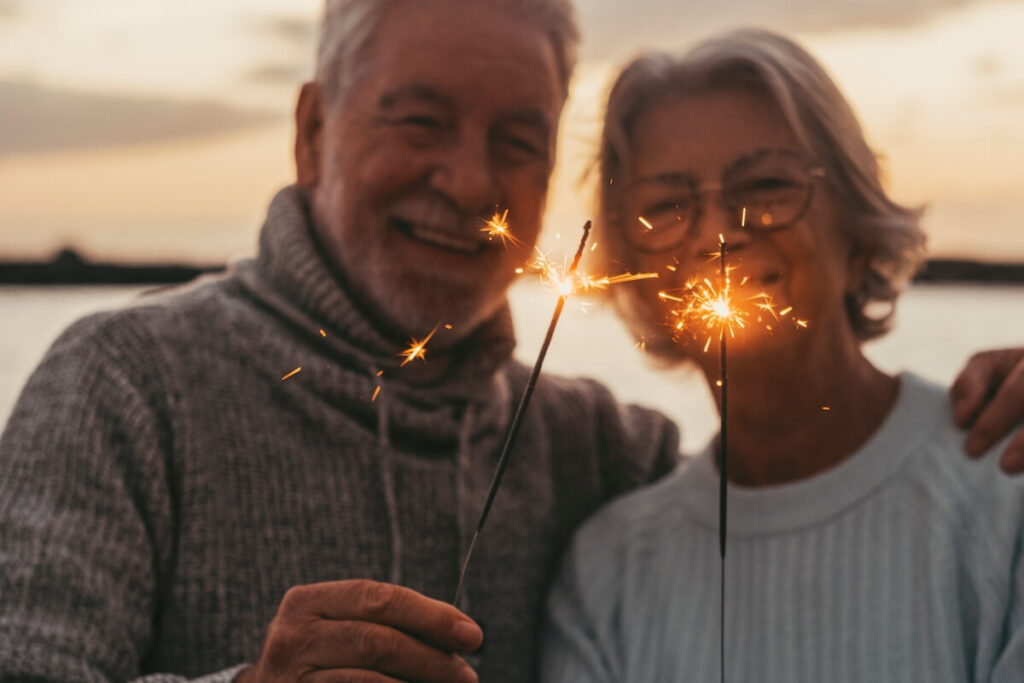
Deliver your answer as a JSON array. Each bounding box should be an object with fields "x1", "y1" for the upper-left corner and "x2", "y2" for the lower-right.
[{"x1": 543, "y1": 375, "x2": 1024, "y2": 683}]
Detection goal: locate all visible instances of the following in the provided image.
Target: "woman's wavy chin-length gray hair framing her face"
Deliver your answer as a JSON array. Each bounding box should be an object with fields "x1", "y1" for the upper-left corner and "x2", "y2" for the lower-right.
[{"x1": 597, "y1": 29, "x2": 925, "y2": 360}]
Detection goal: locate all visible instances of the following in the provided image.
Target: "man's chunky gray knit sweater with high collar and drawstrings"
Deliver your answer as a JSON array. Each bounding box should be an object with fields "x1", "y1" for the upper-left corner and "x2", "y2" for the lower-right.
[{"x1": 0, "y1": 188, "x2": 678, "y2": 683}]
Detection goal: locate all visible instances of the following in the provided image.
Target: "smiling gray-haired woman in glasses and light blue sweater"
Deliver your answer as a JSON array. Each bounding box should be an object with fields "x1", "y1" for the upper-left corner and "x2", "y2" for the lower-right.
[{"x1": 543, "y1": 31, "x2": 1024, "y2": 683}]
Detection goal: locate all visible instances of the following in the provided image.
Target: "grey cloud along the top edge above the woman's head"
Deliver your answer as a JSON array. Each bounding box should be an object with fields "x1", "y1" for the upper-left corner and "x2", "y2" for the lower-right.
[{"x1": 579, "y1": 0, "x2": 993, "y2": 59}]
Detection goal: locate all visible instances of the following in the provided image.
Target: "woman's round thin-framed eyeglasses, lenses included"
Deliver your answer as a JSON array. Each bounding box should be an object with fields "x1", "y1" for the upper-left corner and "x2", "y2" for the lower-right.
[{"x1": 625, "y1": 150, "x2": 824, "y2": 254}]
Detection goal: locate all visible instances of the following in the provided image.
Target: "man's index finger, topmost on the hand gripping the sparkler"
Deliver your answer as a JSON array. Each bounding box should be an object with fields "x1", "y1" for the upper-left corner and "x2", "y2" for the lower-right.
[{"x1": 281, "y1": 580, "x2": 483, "y2": 652}]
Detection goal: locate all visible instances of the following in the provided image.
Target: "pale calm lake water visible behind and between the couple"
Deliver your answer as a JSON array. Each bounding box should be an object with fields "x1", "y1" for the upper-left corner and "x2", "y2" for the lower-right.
[{"x1": 0, "y1": 282, "x2": 1024, "y2": 451}]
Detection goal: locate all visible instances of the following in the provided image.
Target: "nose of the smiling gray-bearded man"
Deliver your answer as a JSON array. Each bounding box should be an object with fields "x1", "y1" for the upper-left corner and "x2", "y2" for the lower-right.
[{"x1": 430, "y1": 134, "x2": 499, "y2": 212}]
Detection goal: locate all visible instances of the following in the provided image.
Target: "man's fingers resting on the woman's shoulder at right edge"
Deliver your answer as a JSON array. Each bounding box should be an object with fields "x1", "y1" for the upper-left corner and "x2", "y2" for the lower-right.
[{"x1": 950, "y1": 347, "x2": 1024, "y2": 474}]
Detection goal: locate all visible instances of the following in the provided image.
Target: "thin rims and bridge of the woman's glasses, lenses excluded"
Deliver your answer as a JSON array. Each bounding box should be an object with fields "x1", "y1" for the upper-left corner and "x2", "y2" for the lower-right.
[{"x1": 624, "y1": 147, "x2": 825, "y2": 254}]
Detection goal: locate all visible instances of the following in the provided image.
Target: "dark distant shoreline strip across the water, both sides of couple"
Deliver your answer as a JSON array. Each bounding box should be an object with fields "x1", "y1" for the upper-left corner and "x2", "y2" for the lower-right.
[{"x1": 0, "y1": 249, "x2": 1024, "y2": 287}]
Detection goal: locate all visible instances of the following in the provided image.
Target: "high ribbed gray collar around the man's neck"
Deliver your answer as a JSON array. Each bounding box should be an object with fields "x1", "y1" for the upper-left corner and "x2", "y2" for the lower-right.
[{"x1": 238, "y1": 185, "x2": 515, "y2": 403}]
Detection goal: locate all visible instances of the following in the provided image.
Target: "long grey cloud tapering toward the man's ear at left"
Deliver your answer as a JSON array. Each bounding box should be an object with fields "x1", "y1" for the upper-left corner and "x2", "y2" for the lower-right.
[{"x1": 0, "y1": 80, "x2": 282, "y2": 157}]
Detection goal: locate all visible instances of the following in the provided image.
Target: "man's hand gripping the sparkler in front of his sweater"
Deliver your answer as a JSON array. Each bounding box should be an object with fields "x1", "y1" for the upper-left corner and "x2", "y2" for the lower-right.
[{"x1": 237, "y1": 580, "x2": 483, "y2": 683}]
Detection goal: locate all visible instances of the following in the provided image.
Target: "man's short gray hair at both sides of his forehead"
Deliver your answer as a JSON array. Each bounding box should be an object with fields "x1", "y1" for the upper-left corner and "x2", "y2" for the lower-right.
[{"x1": 316, "y1": 0, "x2": 580, "y2": 101}]
